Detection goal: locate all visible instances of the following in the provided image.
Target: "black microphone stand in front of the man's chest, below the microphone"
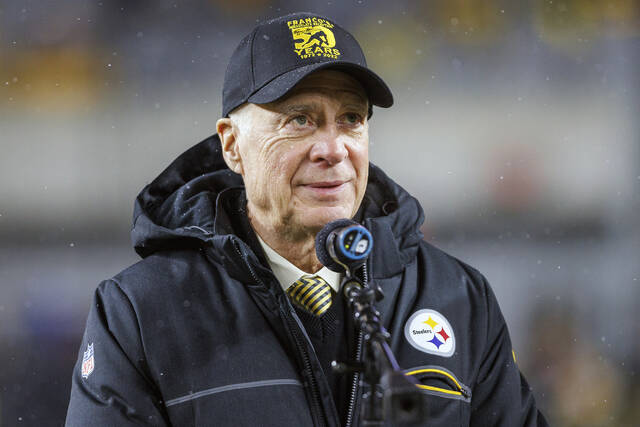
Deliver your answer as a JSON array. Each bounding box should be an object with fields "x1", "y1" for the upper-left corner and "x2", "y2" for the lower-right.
[{"x1": 332, "y1": 268, "x2": 426, "y2": 426}]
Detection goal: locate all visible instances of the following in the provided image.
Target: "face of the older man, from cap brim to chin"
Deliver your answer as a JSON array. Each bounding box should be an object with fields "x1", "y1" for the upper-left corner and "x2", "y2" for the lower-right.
[{"x1": 231, "y1": 70, "x2": 369, "y2": 239}]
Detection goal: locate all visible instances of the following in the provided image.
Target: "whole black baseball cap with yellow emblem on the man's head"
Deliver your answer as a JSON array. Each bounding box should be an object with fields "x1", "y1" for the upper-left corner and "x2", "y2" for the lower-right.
[{"x1": 222, "y1": 12, "x2": 393, "y2": 117}]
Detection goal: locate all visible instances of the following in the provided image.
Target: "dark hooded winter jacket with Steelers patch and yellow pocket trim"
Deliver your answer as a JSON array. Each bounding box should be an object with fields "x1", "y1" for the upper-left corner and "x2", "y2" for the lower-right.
[{"x1": 66, "y1": 136, "x2": 546, "y2": 427}]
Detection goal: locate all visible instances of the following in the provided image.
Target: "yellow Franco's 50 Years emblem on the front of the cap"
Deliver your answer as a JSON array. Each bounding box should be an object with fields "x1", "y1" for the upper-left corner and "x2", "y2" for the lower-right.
[{"x1": 287, "y1": 17, "x2": 340, "y2": 59}]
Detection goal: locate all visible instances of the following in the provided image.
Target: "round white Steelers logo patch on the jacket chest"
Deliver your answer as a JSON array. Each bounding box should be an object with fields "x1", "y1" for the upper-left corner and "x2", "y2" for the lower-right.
[{"x1": 404, "y1": 309, "x2": 456, "y2": 357}]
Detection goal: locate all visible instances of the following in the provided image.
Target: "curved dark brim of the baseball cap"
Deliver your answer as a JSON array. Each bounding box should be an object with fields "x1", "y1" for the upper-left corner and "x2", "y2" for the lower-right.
[{"x1": 247, "y1": 61, "x2": 393, "y2": 108}]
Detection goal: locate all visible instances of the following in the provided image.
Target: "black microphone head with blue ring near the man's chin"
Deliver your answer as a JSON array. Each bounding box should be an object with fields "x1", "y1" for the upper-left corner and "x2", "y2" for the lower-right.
[{"x1": 316, "y1": 218, "x2": 373, "y2": 273}]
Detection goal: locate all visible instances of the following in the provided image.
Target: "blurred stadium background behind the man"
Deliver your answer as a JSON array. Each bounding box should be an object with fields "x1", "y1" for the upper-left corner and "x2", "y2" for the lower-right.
[{"x1": 0, "y1": 0, "x2": 640, "y2": 426}]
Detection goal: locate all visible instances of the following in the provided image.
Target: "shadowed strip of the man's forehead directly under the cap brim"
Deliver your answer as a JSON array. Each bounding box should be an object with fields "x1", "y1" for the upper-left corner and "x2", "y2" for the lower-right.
[{"x1": 272, "y1": 70, "x2": 369, "y2": 109}]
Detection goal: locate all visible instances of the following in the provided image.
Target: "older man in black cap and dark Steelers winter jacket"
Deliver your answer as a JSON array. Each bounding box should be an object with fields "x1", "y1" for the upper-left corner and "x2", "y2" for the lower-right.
[{"x1": 67, "y1": 13, "x2": 546, "y2": 426}]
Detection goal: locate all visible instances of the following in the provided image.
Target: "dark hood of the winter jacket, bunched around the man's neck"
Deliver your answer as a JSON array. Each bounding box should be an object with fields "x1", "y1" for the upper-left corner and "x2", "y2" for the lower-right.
[{"x1": 131, "y1": 135, "x2": 424, "y2": 277}]
